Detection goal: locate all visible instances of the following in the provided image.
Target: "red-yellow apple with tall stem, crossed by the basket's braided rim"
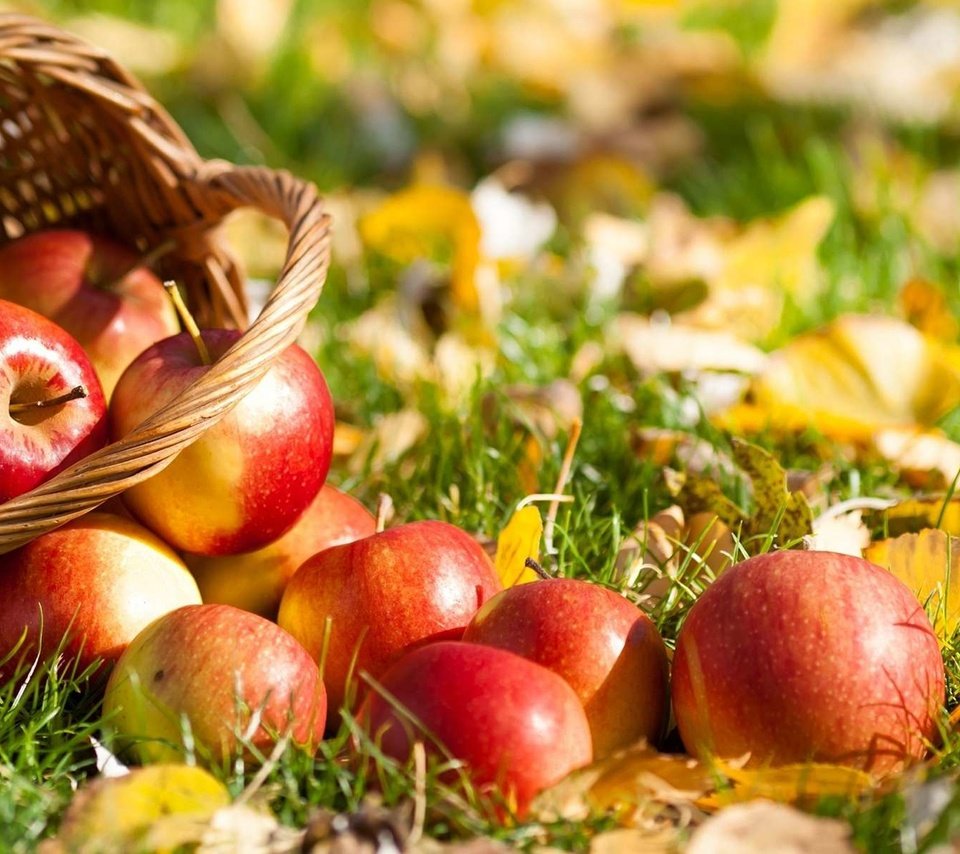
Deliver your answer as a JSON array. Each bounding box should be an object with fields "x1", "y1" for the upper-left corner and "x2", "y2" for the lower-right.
[{"x1": 109, "y1": 329, "x2": 334, "y2": 555}]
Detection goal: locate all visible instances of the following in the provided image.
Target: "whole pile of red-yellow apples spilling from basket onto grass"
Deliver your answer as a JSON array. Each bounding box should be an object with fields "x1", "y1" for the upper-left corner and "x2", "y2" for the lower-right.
[{"x1": 0, "y1": 230, "x2": 944, "y2": 815}]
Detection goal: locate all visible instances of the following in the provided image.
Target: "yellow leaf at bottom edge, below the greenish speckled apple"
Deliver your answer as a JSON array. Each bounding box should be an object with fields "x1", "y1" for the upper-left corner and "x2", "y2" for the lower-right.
[{"x1": 58, "y1": 764, "x2": 230, "y2": 854}]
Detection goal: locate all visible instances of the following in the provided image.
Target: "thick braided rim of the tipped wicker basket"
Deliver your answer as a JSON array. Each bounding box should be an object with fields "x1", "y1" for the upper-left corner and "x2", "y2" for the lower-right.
[{"x1": 0, "y1": 16, "x2": 330, "y2": 553}]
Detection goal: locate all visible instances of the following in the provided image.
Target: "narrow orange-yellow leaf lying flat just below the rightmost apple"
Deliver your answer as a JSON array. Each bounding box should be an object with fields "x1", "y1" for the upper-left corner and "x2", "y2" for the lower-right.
[{"x1": 714, "y1": 760, "x2": 877, "y2": 806}]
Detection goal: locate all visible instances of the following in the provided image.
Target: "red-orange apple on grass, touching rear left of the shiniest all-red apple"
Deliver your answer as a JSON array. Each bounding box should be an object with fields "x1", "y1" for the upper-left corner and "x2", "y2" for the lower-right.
[{"x1": 277, "y1": 520, "x2": 500, "y2": 711}]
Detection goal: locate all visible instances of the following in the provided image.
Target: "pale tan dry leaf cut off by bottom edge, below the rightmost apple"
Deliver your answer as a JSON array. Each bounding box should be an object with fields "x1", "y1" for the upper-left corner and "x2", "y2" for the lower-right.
[{"x1": 684, "y1": 801, "x2": 856, "y2": 854}]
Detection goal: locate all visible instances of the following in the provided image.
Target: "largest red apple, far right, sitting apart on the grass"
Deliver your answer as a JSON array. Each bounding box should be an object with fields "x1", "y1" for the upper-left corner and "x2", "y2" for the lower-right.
[{"x1": 672, "y1": 550, "x2": 944, "y2": 775}]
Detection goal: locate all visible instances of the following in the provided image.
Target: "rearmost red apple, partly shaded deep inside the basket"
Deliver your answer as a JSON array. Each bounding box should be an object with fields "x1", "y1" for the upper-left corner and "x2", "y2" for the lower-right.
[{"x1": 0, "y1": 229, "x2": 180, "y2": 399}]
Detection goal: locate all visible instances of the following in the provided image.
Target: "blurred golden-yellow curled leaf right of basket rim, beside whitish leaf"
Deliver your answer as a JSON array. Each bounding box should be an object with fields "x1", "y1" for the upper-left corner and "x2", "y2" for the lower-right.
[{"x1": 360, "y1": 184, "x2": 480, "y2": 313}]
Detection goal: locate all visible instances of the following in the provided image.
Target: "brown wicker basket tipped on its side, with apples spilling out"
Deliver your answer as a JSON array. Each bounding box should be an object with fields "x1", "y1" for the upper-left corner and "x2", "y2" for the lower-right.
[{"x1": 0, "y1": 15, "x2": 330, "y2": 553}]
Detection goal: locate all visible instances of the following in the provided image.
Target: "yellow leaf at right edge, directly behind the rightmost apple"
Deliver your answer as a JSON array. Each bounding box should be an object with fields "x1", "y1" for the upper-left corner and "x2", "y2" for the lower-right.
[{"x1": 863, "y1": 528, "x2": 960, "y2": 644}]
